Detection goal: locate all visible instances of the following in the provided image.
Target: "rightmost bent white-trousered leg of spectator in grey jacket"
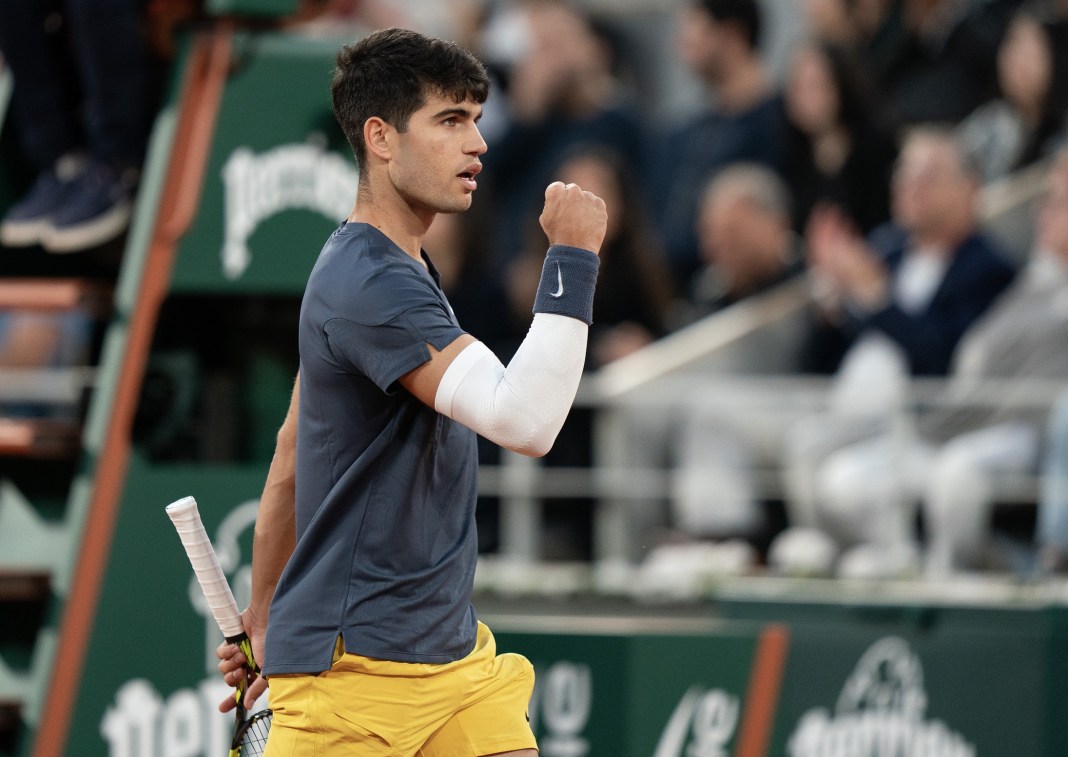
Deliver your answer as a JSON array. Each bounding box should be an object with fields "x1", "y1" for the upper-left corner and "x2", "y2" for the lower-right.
[{"x1": 924, "y1": 424, "x2": 1038, "y2": 574}]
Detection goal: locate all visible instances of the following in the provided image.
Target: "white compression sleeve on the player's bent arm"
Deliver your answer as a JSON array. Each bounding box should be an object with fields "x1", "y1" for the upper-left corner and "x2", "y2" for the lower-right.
[{"x1": 434, "y1": 313, "x2": 590, "y2": 457}]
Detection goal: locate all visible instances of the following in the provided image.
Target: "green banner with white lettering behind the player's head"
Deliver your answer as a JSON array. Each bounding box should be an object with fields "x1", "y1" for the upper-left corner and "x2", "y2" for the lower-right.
[{"x1": 171, "y1": 33, "x2": 358, "y2": 295}]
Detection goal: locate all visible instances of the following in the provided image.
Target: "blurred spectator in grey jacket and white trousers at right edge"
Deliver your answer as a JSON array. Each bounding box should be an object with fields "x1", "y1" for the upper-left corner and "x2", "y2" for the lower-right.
[{"x1": 786, "y1": 146, "x2": 1068, "y2": 574}]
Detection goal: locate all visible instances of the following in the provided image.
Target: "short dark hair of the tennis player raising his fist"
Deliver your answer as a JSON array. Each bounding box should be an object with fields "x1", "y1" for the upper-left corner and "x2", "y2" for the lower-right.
[{"x1": 331, "y1": 29, "x2": 489, "y2": 170}]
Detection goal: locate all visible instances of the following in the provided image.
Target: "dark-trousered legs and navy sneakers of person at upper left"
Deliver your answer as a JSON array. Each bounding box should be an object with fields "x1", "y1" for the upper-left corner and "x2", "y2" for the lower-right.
[{"x1": 0, "y1": 0, "x2": 155, "y2": 252}]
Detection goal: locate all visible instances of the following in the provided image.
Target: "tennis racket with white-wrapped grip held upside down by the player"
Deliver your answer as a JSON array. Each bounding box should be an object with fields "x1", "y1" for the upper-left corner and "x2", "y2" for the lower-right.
[{"x1": 167, "y1": 496, "x2": 271, "y2": 757}]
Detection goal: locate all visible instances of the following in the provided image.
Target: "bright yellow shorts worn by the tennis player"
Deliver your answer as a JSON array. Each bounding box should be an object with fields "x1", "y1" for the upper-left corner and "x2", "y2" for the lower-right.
[{"x1": 265, "y1": 622, "x2": 537, "y2": 757}]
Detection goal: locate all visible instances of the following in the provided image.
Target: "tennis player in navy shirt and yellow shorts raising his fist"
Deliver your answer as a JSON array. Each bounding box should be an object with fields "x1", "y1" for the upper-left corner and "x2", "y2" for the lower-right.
[{"x1": 218, "y1": 29, "x2": 607, "y2": 757}]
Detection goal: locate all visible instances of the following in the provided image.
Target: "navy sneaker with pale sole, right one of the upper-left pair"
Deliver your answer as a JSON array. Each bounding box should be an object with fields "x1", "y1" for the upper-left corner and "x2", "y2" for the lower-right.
[{"x1": 42, "y1": 160, "x2": 137, "y2": 252}]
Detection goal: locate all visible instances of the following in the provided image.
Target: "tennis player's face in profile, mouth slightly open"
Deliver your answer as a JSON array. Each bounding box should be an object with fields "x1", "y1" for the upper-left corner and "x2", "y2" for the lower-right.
[{"x1": 390, "y1": 95, "x2": 486, "y2": 214}]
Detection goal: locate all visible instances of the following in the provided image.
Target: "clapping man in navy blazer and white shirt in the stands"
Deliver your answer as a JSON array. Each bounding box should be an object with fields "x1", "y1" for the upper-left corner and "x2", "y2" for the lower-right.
[{"x1": 783, "y1": 127, "x2": 1014, "y2": 568}]
